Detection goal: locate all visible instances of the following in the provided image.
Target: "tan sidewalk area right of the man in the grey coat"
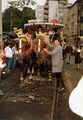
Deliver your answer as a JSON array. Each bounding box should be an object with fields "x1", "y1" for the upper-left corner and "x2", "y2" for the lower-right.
[{"x1": 63, "y1": 57, "x2": 83, "y2": 92}]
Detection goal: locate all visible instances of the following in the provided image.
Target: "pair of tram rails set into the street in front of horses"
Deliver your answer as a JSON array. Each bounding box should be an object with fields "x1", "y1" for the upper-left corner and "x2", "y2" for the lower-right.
[{"x1": 0, "y1": 72, "x2": 62, "y2": 120}]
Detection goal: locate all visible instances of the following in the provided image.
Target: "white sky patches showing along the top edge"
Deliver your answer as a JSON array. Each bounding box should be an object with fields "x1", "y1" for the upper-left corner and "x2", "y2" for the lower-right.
[{"x1": 2, "y1": 0, "x2": 76, "y2": 11}]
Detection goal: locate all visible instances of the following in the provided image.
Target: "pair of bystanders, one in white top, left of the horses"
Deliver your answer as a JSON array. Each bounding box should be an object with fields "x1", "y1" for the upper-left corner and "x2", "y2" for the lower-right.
[{"x1": 4, "y1": 40, "x2": 18, "y2": 72}]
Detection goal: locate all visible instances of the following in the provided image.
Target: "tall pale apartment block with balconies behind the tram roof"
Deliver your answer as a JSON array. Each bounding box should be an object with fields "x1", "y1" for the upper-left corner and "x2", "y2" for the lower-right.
[{"x1": 36, "y1": 0, "x2": 68, "y2": 23}]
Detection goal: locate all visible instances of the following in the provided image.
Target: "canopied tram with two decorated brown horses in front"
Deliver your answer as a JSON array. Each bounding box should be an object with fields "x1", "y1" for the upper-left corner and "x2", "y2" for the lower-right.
[{"x1": 14, "y1": 23, "x2": 63, "y2": 80}]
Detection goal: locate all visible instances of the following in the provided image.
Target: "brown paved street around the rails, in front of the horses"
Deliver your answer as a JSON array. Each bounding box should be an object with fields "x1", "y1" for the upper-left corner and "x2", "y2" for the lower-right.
[{"x1": 0, "y1": 57, "x2": 83, "y2": 120}]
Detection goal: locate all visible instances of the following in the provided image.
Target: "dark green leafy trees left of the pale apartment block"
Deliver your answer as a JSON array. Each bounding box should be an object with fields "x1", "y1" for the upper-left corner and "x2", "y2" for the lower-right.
[{"x1": 2, "y1": 7, "x2": 35, "y2": 32}]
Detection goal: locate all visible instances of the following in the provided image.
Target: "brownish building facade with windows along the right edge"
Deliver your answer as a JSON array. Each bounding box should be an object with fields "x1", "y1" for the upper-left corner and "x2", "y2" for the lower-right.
[{"x1": 66, "y1": 0, "x2": 83, "y2": 43}]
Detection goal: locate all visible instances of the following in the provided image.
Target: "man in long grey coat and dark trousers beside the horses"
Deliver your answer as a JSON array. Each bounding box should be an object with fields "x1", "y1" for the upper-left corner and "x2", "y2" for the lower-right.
[{"x1": 44, "y1": 37, "x2": 65, "y2": 91}]
